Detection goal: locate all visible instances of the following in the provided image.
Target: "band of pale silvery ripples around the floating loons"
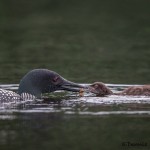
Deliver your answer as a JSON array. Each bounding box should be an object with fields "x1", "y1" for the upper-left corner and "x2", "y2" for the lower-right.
[{"x1": 0, "y1": 84, "x2": 150, "y2": 115}]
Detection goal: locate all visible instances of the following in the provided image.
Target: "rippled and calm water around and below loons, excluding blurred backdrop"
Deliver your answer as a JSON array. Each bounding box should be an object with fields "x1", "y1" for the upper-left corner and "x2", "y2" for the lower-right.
[{"x1": 0, "y1": 84, "x2": 150, "y2": 150}]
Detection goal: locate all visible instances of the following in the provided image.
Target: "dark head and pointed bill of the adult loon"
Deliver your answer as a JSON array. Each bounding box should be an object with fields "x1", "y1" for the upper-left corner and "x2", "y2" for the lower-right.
[{"x1": 18, "y1": 69, "x2": 84, "y2": 98}]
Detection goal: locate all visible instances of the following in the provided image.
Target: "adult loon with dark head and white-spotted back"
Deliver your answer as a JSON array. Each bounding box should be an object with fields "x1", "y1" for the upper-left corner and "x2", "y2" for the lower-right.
[{"x1": 0, "y1": 69, "x2": 84, "y2": 103}]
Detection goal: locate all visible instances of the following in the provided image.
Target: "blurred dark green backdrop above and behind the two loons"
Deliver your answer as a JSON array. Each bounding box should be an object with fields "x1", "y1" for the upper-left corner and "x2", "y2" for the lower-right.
[{"x1": 0, "y1": 0, "x2": 150, "y2": 84}]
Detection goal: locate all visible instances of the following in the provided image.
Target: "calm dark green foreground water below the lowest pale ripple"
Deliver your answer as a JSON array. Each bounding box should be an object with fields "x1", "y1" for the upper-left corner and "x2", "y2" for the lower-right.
[{"x1": 0, "y1": 114, "x2": 150, "y2": 150}]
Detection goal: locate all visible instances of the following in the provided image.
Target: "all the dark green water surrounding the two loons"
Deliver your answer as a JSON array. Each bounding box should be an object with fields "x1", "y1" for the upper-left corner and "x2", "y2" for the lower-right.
[{"x1": 0, "y1": 0, "x2": 150, "y2": 150}]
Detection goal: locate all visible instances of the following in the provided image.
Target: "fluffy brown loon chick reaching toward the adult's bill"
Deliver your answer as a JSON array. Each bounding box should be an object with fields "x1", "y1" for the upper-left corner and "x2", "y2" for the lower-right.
[{"x1": 89, "y1": 82, "x2": 150, "y2": 96}]
